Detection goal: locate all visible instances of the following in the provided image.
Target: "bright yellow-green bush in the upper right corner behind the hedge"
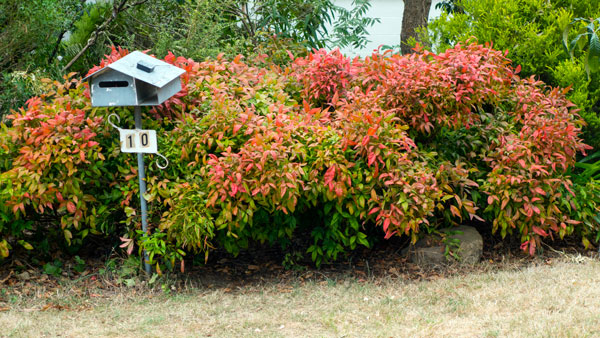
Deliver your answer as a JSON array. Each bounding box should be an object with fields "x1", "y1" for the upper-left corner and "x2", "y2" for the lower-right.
[{"x1": 423, "y1": 0, "x2": 600, "y2": 149}]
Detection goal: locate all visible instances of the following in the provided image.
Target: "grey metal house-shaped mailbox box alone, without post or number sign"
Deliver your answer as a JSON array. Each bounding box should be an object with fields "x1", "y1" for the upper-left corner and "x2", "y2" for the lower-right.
[{"x1": 84, "y1": 51, "x2": 185, "y2": 107}]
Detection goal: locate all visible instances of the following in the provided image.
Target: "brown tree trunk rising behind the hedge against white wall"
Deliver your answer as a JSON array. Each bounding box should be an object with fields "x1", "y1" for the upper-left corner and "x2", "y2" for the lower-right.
[{"x1": 400, "y1": 0, "x2": 431, "y2": 54}]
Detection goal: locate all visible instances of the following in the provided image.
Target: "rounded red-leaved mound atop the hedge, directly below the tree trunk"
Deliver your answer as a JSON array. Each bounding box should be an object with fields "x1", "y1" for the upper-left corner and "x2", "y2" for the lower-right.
[{"x1": 360, "y1": 45, "x2": 514, "y2": 133}]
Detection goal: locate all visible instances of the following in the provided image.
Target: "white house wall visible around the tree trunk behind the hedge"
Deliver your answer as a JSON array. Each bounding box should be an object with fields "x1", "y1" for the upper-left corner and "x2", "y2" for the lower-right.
[{"x1": 335, "y1": 0, "x2": 441, "y2": 56}]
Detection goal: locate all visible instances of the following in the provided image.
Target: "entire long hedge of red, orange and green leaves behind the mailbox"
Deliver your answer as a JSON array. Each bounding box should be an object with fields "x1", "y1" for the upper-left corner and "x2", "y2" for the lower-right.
[{"x1": 0, "y1": 44, "x2": 600, "y2": 267}]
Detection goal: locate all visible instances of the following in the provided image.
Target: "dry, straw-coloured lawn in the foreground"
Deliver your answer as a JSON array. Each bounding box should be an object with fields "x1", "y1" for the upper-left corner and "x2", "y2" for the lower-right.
[{"x1": 0, "y1": 256, "x2": 600, "y2": 337}]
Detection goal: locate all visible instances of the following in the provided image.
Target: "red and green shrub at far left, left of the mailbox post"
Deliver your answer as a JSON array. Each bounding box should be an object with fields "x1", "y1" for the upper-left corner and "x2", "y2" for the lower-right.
[{"x1": 2, "y1": 75, "x2": 105, "y2": 246}]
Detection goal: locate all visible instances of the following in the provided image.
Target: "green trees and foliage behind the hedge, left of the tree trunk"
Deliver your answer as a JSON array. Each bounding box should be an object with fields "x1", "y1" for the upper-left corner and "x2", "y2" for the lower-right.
[{"x1": 0, "y1": 0, "x2": 376, "y2": 118}]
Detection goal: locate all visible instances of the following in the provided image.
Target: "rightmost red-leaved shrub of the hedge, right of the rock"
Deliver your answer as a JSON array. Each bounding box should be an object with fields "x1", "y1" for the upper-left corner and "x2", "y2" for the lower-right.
[{"x1": 482, "y1": 79, "x2": 590, "y2": 254}]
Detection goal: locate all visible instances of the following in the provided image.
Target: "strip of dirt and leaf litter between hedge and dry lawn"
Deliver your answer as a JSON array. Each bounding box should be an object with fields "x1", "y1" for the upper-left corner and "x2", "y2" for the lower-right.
[{"x1": 0, "y1": 233, "x2": 596, "y2": 311}]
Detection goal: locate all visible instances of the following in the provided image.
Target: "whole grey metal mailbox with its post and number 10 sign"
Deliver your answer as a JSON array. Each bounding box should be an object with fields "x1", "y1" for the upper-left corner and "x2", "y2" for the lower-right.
[{"x1": 84, "y1": 51, "x2": 185, "y2": 273}]
